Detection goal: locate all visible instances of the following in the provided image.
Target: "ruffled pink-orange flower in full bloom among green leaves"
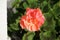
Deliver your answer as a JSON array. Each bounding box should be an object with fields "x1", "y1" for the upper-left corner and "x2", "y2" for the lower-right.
[{"x1": 20, "y1": 8, "x2": 45, "y2": 31}]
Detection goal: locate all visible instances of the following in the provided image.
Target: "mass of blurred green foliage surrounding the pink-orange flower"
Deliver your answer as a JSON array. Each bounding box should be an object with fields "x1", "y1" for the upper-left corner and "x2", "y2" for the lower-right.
[{"x1": 7, "y1": 0, "x2": 60, "y2": 40}]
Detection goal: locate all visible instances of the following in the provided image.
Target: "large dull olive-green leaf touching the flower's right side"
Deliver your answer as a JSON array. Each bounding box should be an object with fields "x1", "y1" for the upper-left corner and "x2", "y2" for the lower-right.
[{"x1": 41, "y1": 13, "x2": 56, "y2": 31}]
